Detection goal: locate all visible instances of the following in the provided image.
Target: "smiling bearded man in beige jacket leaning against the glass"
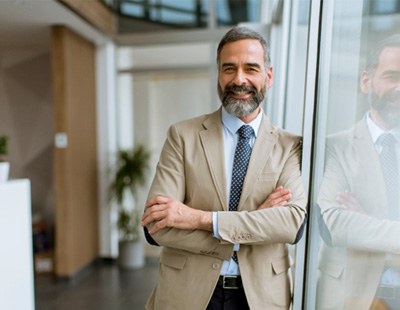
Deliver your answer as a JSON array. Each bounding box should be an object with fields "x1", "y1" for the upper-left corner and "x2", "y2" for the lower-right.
[{"x1": 142, "y1": 27, "x2": 306, "y2": 310}]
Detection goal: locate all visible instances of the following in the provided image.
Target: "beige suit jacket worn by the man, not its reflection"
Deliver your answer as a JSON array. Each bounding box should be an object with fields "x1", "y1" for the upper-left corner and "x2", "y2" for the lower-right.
[{"x1": 146, "y1": 110, "x2": 306, "y2": 310}]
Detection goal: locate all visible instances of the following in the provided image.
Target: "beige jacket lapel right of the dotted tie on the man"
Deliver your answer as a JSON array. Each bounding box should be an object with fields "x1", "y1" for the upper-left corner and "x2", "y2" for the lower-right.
[{"x1": 238, "y1": 114, "x2": 278, "y2": 210}]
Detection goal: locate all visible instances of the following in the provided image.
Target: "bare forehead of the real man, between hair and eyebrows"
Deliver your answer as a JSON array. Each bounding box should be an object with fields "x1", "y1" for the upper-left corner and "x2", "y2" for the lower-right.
[{"x1": 220, "y1": 39, "x2": 264, "y2": 65}]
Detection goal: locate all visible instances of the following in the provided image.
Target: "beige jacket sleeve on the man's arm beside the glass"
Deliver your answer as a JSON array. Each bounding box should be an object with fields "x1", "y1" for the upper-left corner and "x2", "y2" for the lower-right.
[{"x1": 218, "y1": 139, "x2": 307, "y2": 244}]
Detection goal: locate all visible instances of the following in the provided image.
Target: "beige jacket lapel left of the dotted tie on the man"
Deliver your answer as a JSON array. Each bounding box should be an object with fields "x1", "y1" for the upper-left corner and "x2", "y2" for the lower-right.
[{"x1": 200, "y1": 109, "x2": 228, "y2": 210}]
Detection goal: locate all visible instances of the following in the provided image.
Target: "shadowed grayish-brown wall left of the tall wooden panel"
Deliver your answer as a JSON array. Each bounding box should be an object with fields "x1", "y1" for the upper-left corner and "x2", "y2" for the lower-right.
[{"x1": 0, "y1": 48, "x2": 54, "y2": 226}]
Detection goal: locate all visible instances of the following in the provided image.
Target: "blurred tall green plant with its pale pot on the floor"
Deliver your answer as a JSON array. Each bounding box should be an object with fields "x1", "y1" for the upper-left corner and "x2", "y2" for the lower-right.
[{"x1": 110, "y1": 145, "x2": 150, "y2": 268}]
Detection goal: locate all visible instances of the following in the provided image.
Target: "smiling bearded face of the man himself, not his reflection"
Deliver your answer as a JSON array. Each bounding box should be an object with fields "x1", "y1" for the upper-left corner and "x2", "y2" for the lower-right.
[{"x1": 218, "y1": 39, "x2": 272, "y2": 118}]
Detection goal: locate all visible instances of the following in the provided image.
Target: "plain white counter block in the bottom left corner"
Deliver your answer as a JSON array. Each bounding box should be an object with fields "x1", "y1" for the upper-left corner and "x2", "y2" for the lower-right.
[{"x1": 0, "y1": 180, "x2": 35, "y2": 310}]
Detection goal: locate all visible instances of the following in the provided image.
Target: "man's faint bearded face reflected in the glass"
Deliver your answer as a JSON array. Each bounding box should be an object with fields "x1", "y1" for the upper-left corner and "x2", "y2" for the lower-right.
[{"x1": 361, "y1": 47, "x2": 400, "y2": 128}]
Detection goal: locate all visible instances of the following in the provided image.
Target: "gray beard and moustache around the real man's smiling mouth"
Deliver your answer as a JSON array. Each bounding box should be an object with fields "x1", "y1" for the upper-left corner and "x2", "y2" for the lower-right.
[{"x1": 218, "y1": 84, "x2": 266, "y2": 118}]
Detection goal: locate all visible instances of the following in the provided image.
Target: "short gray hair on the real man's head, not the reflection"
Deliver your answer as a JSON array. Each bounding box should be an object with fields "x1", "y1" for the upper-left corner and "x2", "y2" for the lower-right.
[{"x1": 217, "y1": 27, "x2": 271, "y2": 69}]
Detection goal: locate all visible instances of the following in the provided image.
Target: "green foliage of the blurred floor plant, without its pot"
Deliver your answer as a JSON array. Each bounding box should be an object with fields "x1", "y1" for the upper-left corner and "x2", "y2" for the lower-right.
[{"x1": 109, "y1": 145, "x2": 150, "y2": 241}]
